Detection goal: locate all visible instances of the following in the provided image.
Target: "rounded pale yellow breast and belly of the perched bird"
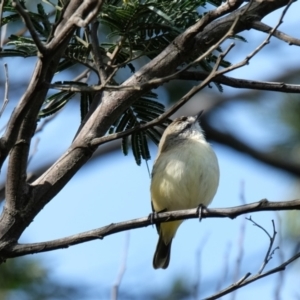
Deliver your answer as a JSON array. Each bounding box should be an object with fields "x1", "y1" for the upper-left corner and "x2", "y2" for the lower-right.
[{"x1": 151, "y1": 140, "x2": 219, "y2": 212}]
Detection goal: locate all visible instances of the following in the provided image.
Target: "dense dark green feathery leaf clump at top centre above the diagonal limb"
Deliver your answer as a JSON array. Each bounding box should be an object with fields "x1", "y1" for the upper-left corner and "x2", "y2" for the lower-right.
[{"x1": 99, "y1": 0, "x2": 229, "y2": 64}]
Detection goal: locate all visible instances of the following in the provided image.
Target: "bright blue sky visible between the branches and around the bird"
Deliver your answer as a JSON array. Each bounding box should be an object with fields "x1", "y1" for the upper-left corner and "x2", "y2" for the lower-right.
[{"x1": 0, "y1": 2, "x2": 300, "y2": 300}]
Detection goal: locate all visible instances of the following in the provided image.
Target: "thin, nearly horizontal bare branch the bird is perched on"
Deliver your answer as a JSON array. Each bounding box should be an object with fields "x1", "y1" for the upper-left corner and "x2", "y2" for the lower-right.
[{"x1": 1, "y1": 199, "x2": 300, "y2": 258}]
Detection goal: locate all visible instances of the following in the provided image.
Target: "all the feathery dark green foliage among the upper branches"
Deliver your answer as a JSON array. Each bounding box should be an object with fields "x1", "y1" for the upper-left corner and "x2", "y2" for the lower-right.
[{"x1": 0, "y1": 0, "x2": 241, "y2": 164}]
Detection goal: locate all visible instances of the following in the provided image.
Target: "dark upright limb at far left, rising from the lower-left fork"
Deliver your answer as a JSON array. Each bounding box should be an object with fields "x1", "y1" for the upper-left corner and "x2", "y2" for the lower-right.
[{"x1": 0, "y1": 0, "x2": 101, "y2": 248}]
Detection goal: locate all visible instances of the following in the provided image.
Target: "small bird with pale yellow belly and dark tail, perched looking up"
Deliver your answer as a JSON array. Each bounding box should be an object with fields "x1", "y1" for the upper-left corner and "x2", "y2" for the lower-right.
[{"x1": 150, "y1": 111, "x2": 220, "y2": 269}]
